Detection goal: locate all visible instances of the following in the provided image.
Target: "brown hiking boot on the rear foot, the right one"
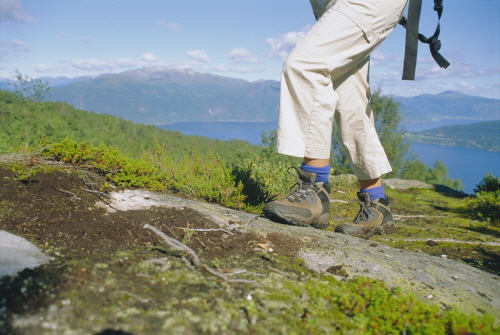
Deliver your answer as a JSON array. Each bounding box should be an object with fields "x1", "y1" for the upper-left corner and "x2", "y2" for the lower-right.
[{"x1": 335, "y1": 192, "x2": 395, "y2": 240}]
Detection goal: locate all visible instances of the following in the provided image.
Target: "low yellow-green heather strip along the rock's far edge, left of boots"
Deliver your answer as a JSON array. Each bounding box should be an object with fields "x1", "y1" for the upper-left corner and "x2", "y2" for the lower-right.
[{"x1": 45, "y1": 139, "x2": 245, "y2": 208}]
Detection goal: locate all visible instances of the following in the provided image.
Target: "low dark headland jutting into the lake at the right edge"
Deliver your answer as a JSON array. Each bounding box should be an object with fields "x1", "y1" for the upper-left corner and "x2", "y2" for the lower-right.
[{"x1": 406, "y1": 120, "x2": 500, "y2": 152}]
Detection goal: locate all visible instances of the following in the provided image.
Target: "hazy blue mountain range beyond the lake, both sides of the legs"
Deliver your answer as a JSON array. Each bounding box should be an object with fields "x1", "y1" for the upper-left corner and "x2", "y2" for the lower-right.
[{"x1": 0, "y1": 68, "x2": 500, "y2": 125}]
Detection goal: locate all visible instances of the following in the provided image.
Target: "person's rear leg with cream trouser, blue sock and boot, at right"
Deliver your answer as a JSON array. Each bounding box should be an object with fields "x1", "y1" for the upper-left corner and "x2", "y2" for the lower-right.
[{"x1": 333, "y1": 56, "x2": 394, "y2": 239}]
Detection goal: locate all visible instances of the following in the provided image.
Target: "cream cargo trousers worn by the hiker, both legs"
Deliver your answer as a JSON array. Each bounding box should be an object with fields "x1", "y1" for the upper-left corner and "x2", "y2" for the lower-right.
[{"x1": 277, "y1": 0, "x2": 407, "y2": 180}]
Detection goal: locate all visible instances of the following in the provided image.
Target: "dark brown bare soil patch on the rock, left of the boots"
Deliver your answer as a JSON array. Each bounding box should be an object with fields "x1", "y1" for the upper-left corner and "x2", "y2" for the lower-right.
[{"x1": 0, "y1": 168, "x2": 300, "y2": 261}]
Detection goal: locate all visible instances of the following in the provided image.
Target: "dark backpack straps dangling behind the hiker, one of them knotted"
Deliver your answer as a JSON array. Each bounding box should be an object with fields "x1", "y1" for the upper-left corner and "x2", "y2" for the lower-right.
[{"x1": 399, "y1": 0, "x2": 450, "y2": 80}]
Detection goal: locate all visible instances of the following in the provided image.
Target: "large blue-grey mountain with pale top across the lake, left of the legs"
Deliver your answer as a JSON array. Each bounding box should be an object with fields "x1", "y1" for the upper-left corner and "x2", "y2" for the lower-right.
[{"x1": 49, "y1": 69, "x2": 279, "y2": 124}]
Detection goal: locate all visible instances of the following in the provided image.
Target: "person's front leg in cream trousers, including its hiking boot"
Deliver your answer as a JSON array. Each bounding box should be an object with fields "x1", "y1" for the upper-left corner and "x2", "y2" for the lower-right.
[{"x1": 264, "y1": 0, "x2": 406, "y2": 227}]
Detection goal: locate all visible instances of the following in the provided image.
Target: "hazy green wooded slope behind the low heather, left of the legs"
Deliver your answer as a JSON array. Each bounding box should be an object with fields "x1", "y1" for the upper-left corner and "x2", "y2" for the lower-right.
[{"x1": 0, "y1": 91, "x2": 259, "y2": 162}]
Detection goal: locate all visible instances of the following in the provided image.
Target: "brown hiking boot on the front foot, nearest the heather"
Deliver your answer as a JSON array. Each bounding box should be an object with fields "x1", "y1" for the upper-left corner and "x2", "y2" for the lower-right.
[{"x1": 263, "y1": 167, "x2": 330, "y2": 228}]
